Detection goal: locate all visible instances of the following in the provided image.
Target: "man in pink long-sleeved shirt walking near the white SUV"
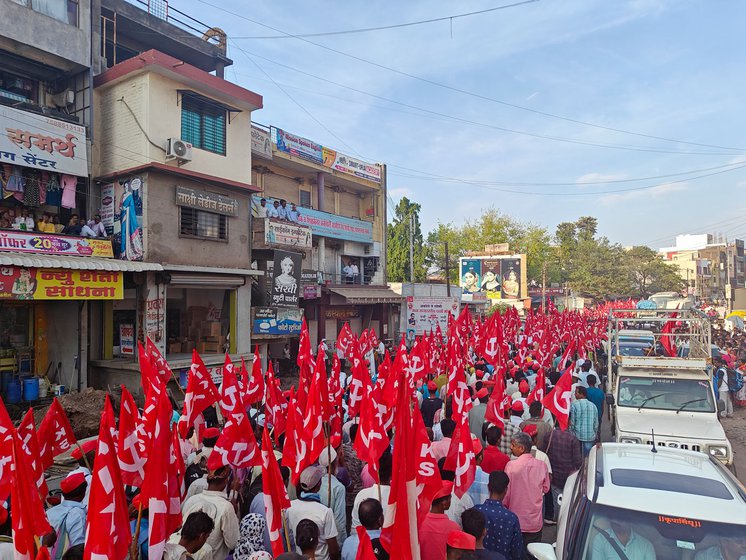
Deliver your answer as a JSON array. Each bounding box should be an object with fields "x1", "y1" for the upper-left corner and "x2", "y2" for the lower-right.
[{"x1": 503, "y1": 432, "x2": 550, "y2": 544}]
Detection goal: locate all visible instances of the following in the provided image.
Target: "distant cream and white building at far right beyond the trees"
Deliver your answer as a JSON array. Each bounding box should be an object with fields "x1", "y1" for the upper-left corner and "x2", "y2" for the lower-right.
[{"x1": 658, "y1": 234, "x2": 746, "y2": 302}]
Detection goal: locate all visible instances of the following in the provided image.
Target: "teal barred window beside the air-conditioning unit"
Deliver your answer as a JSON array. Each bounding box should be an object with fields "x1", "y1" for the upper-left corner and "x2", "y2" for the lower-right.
[{"x1": 181, "y1": 94, "x2": 226, "y2": 156}]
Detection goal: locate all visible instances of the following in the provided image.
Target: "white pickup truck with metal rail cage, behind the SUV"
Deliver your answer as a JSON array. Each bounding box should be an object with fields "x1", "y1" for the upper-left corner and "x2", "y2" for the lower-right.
[{"x1": 606, "y1": 309, "x2": 733, "y2": 466}]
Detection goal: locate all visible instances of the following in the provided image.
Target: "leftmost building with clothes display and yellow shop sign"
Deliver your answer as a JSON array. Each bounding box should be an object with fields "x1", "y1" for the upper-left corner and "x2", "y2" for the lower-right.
[{"x1": 0, "y1": 0, "x2": 97, "y2": 401}]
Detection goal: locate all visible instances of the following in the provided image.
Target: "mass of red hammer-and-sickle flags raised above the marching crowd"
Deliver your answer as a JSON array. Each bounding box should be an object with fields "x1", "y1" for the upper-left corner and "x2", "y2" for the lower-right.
[{"x1": 0, "y1": 302, "x2": 633, "y2": 560}]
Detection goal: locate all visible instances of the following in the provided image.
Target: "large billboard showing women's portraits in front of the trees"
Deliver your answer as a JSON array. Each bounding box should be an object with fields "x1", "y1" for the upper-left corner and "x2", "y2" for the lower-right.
[{"x1": 459, "y1": 255, "x2": 528, "y2": 302}]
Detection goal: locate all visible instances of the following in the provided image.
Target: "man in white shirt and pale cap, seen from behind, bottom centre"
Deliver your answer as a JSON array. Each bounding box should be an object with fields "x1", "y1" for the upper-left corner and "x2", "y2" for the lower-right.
[{"x1": 287, "y1": 465, "x2": 340, "y2": 560}]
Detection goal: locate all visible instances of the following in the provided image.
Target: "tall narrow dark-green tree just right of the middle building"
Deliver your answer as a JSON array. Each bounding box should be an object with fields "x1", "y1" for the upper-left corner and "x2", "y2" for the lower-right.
[{"x1": 386, "y1": 197, "x2": 427, "y2": 282}]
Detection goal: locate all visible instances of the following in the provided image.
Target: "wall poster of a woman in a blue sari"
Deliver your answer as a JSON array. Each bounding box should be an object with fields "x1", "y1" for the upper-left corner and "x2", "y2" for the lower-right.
[{"x1": 112, "y1": 177, "x2": 145, "y2": 261}]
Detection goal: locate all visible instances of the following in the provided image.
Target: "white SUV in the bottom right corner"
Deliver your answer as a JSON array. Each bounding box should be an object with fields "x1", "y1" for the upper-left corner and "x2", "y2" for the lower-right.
[{"x1": 528, "y1": 443, "x2": 746, "y2": 560}]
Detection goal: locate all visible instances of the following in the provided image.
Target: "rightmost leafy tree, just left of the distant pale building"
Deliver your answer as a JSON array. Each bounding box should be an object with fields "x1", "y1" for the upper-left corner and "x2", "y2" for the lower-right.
[{"x1": 624, "y1": 246, "x2": 684, "y2": 298}]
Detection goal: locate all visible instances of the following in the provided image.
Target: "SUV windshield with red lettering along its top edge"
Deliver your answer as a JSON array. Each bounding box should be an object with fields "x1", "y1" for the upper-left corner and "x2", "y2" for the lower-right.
[{"x1": 578, "y1": 504, "x2": 746, "y2": 560}]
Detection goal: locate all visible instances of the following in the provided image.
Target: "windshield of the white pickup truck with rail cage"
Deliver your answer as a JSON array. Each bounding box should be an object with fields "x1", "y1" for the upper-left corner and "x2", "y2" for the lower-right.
[{"x1": 618, "y1": 375, "x2": 715, "y2": 412}]
